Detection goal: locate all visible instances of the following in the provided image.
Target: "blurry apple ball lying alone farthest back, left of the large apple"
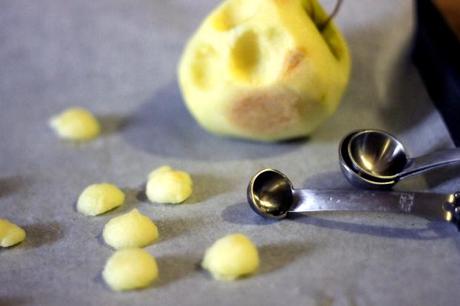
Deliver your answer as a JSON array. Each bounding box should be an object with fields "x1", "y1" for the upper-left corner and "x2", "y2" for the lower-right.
[{"x1": 49, "y1": 107, "x2": 101, "y2": 141}]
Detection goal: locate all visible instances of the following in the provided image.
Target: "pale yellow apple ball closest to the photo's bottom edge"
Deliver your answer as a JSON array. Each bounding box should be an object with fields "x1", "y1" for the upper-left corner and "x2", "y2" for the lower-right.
[{"x1": 102, "y1": 248, "x2": 158, "y2": 291}]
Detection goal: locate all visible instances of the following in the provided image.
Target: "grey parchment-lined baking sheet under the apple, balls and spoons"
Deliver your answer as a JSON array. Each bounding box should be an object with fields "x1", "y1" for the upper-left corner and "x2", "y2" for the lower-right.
[{"x1": 0, "y1": 0, "x2": 460, "y2": 305}]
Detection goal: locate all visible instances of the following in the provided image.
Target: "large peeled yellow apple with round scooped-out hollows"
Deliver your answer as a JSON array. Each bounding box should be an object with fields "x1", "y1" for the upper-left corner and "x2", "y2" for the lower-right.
[{"x1": 178, "y1": 0, "x2": 351, "y2": 141}]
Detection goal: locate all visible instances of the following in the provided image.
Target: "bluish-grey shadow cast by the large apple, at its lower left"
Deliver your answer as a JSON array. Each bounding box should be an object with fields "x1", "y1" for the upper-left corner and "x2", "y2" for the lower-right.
[{"x1": 121, "y1": 81, "x2": 306, "y2": 162}]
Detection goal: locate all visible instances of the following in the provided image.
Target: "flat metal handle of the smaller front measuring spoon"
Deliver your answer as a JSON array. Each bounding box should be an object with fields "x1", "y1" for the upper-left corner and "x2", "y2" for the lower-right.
[{"x1": 290, "y1": 189, "x2": 458, "y2": 221}]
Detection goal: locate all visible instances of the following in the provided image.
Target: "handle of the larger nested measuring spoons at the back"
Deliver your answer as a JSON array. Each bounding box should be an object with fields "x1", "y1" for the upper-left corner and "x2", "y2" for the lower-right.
[{"x1": 400, "y1": 148, "x2": 460, "y2": 179}]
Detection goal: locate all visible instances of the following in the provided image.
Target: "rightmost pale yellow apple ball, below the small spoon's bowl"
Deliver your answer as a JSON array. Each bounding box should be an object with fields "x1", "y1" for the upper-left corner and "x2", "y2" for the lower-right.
[{"x1": 201, "y1": 234, "x2": 259, "y2": 280}]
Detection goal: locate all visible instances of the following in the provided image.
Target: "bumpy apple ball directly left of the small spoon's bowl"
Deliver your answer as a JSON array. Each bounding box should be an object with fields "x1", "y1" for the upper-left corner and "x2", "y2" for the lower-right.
[{"x1": 146, "y1": 166, "x2": 193, "y2": 204}]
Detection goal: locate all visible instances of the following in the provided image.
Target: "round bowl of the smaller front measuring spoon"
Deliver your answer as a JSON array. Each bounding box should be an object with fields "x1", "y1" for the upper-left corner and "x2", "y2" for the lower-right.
[{"x1": 247, "y1": 169, "x2": 294, "y2": 220}]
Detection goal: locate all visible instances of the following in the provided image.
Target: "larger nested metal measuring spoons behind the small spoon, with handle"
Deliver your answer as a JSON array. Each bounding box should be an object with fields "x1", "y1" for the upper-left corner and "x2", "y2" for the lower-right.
[{"x1": 339, "y1": 130, "x2": 460, "y2": 189}]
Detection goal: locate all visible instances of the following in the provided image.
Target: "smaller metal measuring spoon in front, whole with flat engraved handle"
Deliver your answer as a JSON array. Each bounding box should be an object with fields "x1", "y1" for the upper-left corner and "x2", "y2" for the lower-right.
[{"x1": 247, "y1": 169, "x2": 460, "y2": 229}]
